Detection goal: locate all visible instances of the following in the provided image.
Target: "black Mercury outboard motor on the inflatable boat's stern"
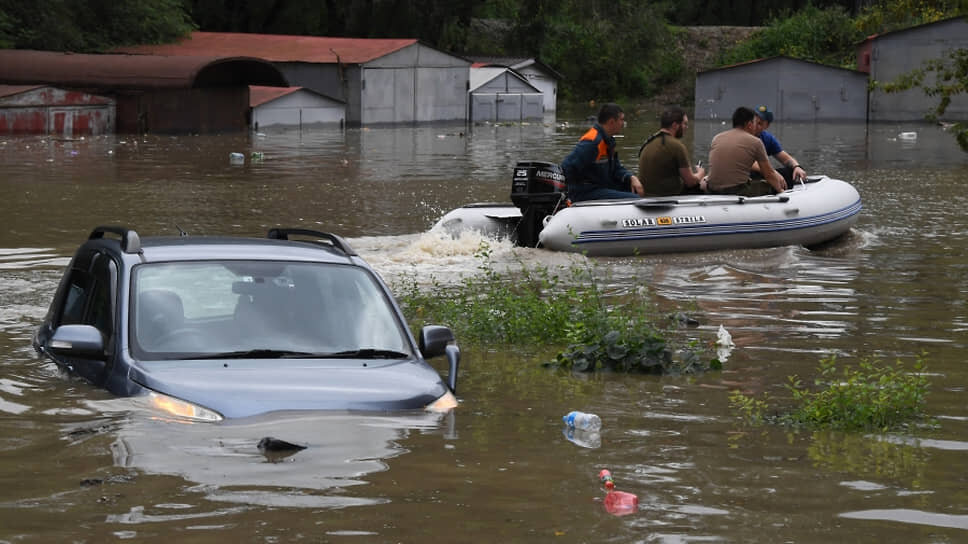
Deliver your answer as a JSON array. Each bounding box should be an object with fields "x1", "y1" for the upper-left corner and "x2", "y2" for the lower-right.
[{"x1": 511, "y1": 161, "x2": 566, "y2": 247}]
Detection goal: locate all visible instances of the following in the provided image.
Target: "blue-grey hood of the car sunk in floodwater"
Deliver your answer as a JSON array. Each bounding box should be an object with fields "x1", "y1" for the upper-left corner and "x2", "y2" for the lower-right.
[{"x1": 130, "y1": 359, "x2": 448, "y2": 418}]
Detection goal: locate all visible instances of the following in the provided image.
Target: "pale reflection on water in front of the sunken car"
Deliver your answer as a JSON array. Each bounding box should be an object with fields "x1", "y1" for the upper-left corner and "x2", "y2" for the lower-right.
[{"x1": 91, "y1": 400, "x2": 446, "y2": 507}]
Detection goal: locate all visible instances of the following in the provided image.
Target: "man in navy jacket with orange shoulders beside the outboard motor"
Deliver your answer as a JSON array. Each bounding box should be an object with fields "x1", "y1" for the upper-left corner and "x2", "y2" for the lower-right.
[{"x1": 561, "y1": 104, "x2": 644, "y2": 202}]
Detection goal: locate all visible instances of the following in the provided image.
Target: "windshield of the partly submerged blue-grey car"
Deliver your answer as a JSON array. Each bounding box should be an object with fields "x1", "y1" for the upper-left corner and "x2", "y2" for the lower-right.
[{"x1": 129, "y1": 261, "x2": 412, "y2": 359}]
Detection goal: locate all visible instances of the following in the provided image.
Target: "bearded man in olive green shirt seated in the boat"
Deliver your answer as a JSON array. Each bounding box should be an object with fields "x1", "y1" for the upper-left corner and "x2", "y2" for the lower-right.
[{"x1": 639, "y1": 107, "x2": 706, "y2": 196}]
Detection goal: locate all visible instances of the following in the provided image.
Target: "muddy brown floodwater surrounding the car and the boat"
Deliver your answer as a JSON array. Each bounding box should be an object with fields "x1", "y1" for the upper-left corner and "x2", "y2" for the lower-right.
[{"x1": 0, "y1": 117, "x2": 968, "y2": 542}]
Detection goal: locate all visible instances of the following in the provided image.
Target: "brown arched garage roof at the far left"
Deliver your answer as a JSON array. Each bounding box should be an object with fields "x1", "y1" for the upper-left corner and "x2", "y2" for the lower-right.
[{"x1": 0, "y1": 49, "x2": 288, "y2": 89}]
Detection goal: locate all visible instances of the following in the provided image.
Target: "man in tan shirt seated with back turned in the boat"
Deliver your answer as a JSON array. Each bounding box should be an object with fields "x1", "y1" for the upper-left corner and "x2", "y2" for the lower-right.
[{"x1": 706, "y1": 107, "x2": 787, "y2": 196}]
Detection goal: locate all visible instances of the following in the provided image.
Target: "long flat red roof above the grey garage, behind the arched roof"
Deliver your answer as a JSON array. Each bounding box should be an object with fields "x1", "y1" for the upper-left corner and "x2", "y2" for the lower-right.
[{"x1": 118, "y1": 32, "x2": 417, "y2": 64}]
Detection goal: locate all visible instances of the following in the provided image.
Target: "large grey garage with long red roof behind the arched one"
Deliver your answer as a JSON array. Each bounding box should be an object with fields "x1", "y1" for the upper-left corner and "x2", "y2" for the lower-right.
[{"x1": 120, "y1": 32, "x2": 470, "y2": 126}]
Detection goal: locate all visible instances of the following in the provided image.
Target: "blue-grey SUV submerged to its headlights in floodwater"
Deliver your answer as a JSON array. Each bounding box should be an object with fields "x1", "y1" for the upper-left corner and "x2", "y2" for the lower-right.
[{"x1": 33, "y1": 226, "x2": 460, "y2": 421}]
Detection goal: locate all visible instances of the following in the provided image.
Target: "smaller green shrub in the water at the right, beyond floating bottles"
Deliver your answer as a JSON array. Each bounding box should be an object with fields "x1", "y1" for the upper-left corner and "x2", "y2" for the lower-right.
[{"x1": 729, "y1": 356, "x2": 928, "y2": 431}]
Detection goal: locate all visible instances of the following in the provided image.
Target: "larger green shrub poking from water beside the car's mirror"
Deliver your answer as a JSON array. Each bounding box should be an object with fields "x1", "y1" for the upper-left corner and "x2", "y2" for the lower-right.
[{"x1": 397, "y1": 242, "x2": 720, "y2": 374}]
